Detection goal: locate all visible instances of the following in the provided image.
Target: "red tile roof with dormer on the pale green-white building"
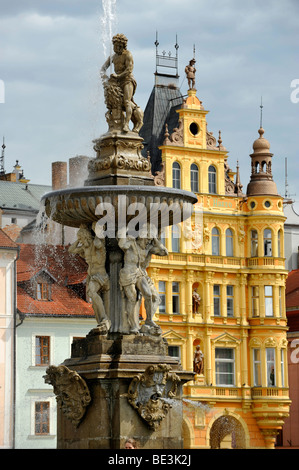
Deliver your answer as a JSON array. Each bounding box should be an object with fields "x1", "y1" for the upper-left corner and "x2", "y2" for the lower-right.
[{"x1": 17, "y1": 244, "x2": 94, "y2": 317}]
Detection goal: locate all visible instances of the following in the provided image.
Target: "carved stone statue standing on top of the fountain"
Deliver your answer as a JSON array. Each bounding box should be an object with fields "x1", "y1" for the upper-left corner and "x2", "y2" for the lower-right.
[{"x1": 101, "y1": 34, "x2": 143, "y2": 133}]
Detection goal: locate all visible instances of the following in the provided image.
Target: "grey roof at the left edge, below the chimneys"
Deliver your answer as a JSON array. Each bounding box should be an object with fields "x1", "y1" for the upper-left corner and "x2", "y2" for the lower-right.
[{"x1": 0, "y1": 181, "x2": 52, "y2": 212}]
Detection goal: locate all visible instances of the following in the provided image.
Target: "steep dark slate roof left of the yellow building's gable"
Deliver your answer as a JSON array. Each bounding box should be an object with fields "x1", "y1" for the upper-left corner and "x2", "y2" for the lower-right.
[{"x1": 140, "y1": 84, "x2": 183, "y2": 174}]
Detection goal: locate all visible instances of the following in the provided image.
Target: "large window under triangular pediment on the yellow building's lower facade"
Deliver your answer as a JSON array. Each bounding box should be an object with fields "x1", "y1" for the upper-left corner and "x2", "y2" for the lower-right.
[{"x1": 215, "y1": 348, "x2": 235, "y2": 386}]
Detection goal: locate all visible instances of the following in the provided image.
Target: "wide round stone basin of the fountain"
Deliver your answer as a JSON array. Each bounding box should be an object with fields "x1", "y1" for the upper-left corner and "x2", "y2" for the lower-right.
[{"x1": 42, "y1": 185, "x2": 197, "y2": 232}]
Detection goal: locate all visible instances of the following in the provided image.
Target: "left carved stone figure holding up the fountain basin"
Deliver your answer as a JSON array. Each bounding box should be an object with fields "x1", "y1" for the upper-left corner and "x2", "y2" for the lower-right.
[{"x1": 69, "y1": 225, "x2": 110, "y2": 333}]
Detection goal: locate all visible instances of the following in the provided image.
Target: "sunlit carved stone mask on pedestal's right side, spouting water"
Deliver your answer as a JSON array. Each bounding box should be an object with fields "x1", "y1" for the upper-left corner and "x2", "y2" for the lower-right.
[{"x1": 128, "y1": 364, "x2": 180, "y2": 430}]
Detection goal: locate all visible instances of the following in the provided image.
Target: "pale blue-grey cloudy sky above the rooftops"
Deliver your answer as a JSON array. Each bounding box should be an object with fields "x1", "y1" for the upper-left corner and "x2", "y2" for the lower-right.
[{"x1": 0, "y1": 0, "x2": 299, "y2": 201}]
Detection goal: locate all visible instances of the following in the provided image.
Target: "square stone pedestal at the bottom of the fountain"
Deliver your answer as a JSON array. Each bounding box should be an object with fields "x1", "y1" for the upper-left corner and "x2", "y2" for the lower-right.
[{"x1": 57, "y1": 328, "x2": 194, "y2": 449}]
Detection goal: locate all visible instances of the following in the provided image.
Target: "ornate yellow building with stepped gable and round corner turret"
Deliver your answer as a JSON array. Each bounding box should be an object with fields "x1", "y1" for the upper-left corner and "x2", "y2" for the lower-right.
[{"x1": 144, "y1": 83, "x2": 290, "y2": 449}]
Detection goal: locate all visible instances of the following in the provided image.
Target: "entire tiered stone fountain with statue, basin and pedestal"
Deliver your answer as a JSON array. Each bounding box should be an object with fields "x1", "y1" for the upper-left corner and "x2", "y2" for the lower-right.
[{"x1": 42, "y1": 34, "x2": 197, "y2": 449}]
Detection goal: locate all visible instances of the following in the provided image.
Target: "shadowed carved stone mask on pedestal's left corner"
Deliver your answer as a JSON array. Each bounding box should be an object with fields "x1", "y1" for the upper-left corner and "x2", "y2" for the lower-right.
[{"x1": 44, "y1": 365, "x2": 91, "y2": 427}]
